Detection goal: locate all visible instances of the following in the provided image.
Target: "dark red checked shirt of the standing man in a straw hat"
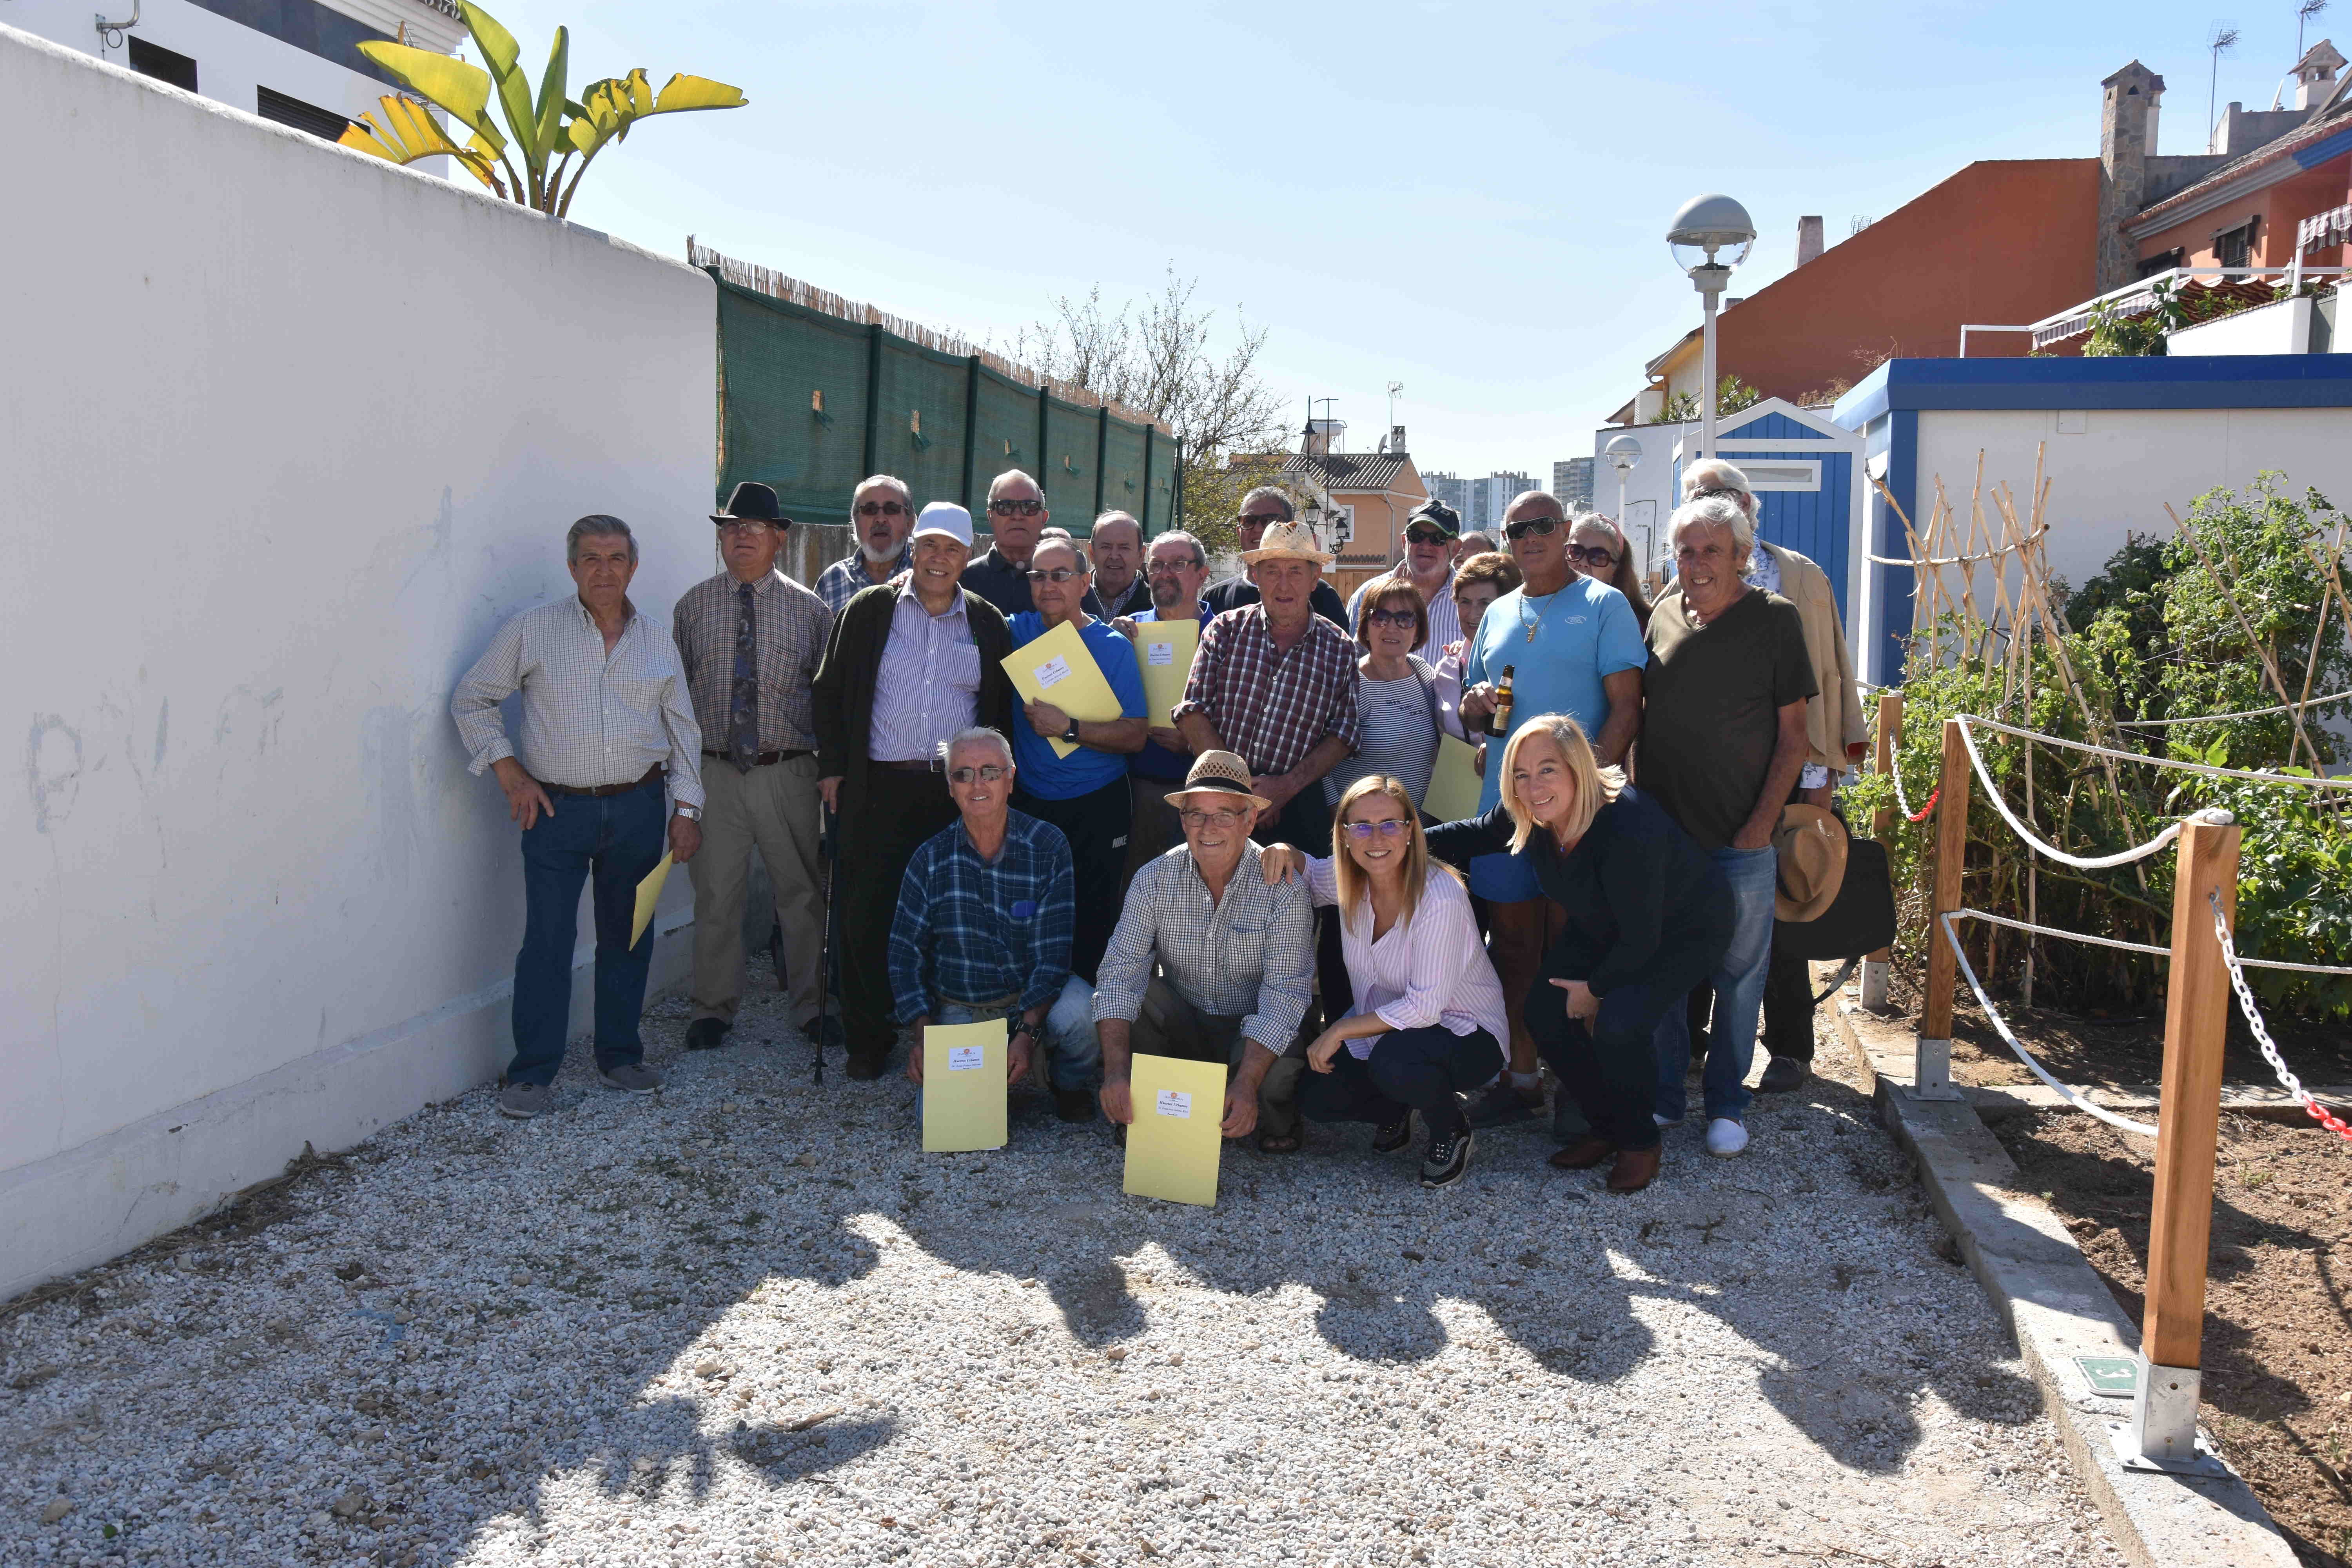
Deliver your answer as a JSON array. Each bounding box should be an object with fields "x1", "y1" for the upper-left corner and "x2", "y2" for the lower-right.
[{"x1": 1176, "y1": 604, "x2": 1362, "y2": 773}]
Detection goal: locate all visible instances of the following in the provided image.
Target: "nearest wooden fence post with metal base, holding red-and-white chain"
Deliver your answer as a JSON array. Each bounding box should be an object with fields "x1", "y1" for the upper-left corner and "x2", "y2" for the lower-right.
[{"x1": 2117, "y1": 818, "x2": 2239, "y2": 1469}]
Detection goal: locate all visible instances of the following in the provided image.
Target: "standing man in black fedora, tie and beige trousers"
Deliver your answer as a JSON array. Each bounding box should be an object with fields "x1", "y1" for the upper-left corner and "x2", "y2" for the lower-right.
[{"x1": 673, "y1": 479, "x2": 833, "y2": 1051}]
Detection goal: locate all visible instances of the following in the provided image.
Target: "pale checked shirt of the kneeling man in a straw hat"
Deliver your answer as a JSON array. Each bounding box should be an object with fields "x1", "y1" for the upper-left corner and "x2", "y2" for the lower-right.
[{"x1": 1094, "y1": 844, "x2": 1315, "y2": 1053}]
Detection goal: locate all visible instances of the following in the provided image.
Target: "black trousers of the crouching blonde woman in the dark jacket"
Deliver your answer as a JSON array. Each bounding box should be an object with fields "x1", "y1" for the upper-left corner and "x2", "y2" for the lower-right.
[{"x1": 1526, "y1": 926, "x2": 1731, "y2": 1150}]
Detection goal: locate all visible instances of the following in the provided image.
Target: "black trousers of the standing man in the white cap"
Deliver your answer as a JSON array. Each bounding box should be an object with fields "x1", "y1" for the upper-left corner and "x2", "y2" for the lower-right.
[{"x1": 833, "y1": 766, "x2": 955, "y2": 1056}]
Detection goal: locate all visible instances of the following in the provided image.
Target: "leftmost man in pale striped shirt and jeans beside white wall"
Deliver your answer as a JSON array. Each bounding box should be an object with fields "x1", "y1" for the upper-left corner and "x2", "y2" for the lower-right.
[{"x1": 449, "y1": 515, "x2": 703, "y2": 1119}]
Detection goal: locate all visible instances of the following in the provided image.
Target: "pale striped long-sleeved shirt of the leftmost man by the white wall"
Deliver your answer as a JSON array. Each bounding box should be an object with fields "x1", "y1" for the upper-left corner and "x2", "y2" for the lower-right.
[{"x1": 449, "y1": 595, "x2": 703, "y2": 806}]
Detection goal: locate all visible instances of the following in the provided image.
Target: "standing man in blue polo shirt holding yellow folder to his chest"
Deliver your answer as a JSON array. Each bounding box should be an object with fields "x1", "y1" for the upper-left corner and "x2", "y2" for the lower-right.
[{"x1": 1011, "y1": 538, "x2": 1145, "y2": 985}]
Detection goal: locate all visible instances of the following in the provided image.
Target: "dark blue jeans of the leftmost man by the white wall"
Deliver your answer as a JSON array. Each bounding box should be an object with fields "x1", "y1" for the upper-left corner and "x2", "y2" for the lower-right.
[{"x1": 506, "y1": 778, "x2": 668, "y2": 1084}]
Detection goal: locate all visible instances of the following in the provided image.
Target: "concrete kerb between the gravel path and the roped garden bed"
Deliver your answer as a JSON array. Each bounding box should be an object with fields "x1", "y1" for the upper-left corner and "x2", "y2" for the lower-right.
[{"x1": 1835, "y1": 995, "x2": 2296, "y2": 1568}]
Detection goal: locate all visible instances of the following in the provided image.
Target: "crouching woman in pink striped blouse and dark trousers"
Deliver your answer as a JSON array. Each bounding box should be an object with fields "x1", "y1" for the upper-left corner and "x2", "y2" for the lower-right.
[{"x1": 1265, "y1": 773, "x2": 1510, "y2": 1187}]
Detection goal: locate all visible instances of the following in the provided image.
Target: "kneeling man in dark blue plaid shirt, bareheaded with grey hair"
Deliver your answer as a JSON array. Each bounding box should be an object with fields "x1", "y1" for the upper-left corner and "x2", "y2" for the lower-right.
[{"x1": 889, "y1": 729, "x2": 1103, "y2": 1122}]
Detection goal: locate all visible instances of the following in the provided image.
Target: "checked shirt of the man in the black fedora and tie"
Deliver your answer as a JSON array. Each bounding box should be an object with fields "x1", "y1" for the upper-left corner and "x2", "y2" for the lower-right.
[{"x1": 673, "y1": 571, "x2": 833, "y2": 752}]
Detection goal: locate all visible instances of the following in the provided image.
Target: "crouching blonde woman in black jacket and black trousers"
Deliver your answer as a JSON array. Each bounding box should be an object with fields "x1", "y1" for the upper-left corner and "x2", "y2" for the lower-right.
[{"x1": 1428, "y1": 712, "x2": 1733, "y2": 1192}]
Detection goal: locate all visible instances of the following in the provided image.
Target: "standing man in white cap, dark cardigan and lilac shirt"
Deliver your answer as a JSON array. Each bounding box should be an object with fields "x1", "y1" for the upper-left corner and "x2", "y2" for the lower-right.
[{"x1": 816, "y1": 501, "x2": 1014, "y2": 1079}]
